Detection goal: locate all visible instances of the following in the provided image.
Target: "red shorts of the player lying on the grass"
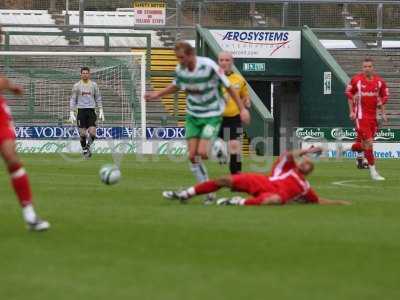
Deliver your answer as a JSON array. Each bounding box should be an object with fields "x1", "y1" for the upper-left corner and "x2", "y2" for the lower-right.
[{"x1": 232, "y1": 173, "x2": 279, "y2": 196}]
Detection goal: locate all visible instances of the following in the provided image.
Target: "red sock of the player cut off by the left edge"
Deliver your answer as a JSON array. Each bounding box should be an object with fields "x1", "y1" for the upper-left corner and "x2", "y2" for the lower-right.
[{"x1": 8, "y1": 164, "x2": 32, "y2": 207}]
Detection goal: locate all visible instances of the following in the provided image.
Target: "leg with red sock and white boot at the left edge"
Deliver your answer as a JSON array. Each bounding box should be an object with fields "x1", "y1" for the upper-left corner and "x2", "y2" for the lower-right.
[{"x1": 0, "y1": 140, "x2": 50, "y2": 231}]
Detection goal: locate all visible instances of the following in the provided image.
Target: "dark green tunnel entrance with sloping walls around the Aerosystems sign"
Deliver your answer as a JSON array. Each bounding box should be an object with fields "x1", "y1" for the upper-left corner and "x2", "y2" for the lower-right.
[{"x1": 196, "y1": 26, "x2": 352, "y2": 154}]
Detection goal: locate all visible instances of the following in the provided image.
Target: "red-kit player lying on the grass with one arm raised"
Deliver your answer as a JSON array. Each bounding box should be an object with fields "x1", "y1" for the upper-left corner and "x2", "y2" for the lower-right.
[{"x1": 163, "y1": 147, "x2": 350, "y2": 205}]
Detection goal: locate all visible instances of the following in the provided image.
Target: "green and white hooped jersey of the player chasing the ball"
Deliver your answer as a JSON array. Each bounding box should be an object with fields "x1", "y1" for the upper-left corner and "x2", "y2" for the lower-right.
[{"x1": 173, "y1": 56, "x2": 231, "y2": 118}]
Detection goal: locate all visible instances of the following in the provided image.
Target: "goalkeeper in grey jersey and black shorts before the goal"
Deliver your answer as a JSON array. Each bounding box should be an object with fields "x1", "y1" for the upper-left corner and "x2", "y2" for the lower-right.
[{"x1": 69, "y1": 67, "x2": 104, "y2": 158}]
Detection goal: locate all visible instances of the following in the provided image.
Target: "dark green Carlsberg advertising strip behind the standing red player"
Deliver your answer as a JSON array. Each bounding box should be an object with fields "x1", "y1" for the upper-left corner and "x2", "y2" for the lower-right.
[{"x1": 294, "y1": 127, "x2": 400, "y2": 143}]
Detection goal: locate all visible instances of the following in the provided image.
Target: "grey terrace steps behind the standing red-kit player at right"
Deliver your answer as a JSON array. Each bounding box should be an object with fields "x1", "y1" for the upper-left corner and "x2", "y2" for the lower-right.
[{"x1": 330, "y1": 49, "x2": 400, "y2": 128}]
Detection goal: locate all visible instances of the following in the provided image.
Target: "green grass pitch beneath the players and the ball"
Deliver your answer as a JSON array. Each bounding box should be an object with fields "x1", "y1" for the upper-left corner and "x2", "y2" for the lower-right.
[{"x1": 0, "y1": 155, "x2": 400, "y2": 300}]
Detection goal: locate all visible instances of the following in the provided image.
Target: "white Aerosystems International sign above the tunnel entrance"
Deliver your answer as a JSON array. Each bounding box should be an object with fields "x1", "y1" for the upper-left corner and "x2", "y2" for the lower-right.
[{"x1": 210, "y1": 30, "x2": 301, "y2": 59}]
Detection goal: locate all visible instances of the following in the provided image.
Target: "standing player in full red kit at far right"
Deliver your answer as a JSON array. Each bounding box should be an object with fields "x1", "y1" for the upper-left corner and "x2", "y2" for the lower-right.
[{"x1": 346, "y1": 58, "x2": 389, "y2": 180}]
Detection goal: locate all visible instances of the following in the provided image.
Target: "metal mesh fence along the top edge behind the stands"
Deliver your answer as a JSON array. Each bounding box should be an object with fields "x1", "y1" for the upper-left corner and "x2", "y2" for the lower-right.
[{"x1": 0, "y1": 0, "x2": 400, "y2": 29}]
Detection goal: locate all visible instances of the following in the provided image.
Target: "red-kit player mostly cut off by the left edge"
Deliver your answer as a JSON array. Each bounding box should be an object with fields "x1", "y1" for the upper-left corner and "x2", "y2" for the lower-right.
[{"x1": 0, "y1": 67, "x2": 50, "y2": 231}]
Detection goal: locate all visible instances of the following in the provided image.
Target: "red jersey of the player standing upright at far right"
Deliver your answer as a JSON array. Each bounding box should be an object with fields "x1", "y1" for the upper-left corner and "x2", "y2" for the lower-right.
[{"x1": 346, "y1": 73, "x2": 389, "y2": 120}]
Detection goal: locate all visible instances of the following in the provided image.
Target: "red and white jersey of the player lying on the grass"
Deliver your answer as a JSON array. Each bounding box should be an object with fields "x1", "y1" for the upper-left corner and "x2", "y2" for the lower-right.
[{"x1": 268, "y1": 153, "x2": 318, "y2": 203}]
